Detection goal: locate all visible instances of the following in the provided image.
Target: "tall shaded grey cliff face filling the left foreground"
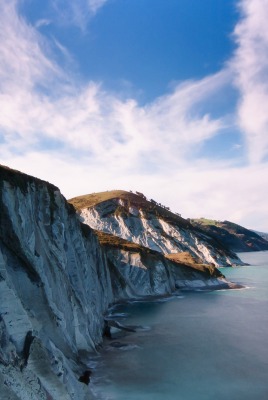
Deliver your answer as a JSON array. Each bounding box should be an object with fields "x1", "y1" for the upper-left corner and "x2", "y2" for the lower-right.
[{"x1": 0, "y1": 167, "x2": 113, "y2": 400}]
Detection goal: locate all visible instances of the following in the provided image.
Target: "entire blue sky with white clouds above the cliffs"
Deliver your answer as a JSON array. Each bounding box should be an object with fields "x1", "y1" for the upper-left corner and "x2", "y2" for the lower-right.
[{"x1": 0, "y1": 0, "x2": 268, "y2": 232}]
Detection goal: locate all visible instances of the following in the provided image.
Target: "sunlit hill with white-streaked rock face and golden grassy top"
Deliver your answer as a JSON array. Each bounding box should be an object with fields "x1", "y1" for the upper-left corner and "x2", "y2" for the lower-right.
[{"x1": 69, "y1": 190, "x2": 242, "y2": 267}]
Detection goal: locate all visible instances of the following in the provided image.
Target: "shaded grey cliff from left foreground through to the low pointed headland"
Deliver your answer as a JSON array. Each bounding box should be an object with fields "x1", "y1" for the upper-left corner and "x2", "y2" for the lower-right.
[{"x1": 0, "y1": 167, "x2": 239, "y2": 400}]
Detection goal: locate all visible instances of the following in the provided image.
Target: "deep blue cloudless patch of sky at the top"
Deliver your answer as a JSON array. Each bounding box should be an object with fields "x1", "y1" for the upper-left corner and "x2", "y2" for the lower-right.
[{"x1": 22, "y1": 0, "x2": 238, "y2": 101}]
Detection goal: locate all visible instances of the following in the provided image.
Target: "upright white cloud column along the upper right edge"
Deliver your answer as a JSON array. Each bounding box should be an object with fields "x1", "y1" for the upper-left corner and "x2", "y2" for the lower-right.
[{"x1": 231, "y1": 0, "x2": 268, "y2": 163}]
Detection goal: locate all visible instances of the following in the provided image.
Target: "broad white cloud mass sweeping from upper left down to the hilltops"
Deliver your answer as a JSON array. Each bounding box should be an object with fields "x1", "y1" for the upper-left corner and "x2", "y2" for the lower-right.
[{"x1": 0, "y1": 0, "x2": 268, "y2": 230}]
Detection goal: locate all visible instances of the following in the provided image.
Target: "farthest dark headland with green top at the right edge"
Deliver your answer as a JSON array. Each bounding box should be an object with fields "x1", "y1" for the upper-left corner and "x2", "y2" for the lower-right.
[{"x1": 191, "y1": 218, "x2": 268, "y2": 252}]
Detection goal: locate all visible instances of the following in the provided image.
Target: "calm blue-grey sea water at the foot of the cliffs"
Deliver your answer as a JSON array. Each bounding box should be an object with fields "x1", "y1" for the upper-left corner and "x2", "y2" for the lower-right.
[{"x1": 92, "y1": 252, "x2": 268, "y2": 400}]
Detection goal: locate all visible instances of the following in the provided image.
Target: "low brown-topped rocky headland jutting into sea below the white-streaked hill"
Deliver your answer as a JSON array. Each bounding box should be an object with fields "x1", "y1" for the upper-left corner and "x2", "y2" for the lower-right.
[{"x1": 96, "y1": 231, "x2": 235, "y2": 299}]
